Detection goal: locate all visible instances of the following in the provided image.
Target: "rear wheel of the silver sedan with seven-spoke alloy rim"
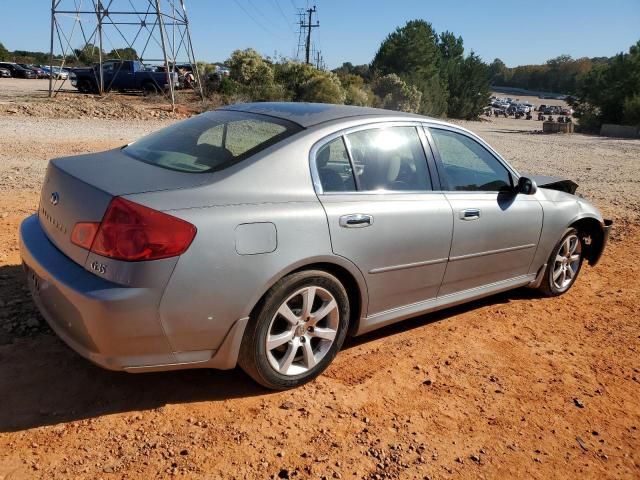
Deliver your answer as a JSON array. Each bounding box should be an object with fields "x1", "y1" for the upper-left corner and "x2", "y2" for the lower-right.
[{"x1": 238, "y1": 270, "x2": 349, "y2": 390}]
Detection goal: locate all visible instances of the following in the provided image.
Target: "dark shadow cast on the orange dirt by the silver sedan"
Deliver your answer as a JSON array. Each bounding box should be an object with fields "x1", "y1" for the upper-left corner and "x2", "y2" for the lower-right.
[{"x1": 0, "y1": 265, "x2": 535, "y2": 432}]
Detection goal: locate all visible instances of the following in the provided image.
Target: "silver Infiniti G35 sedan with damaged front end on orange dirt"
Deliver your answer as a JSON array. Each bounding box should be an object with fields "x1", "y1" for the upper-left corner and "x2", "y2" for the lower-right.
[{"x1": 20, "y1": 103, "x2": 611, "y2": 389}]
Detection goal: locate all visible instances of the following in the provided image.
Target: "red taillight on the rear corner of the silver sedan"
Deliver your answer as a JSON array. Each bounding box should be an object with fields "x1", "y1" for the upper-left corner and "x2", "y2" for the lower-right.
[{"x1": 71, "y1": 197, "x2": 196, "y2": 261}]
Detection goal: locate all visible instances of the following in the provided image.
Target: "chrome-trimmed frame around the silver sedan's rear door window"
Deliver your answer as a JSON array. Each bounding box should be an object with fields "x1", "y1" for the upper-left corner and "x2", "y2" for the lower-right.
[{"x1": 309, "y1": 120, "x2": 441, "y2": 195}]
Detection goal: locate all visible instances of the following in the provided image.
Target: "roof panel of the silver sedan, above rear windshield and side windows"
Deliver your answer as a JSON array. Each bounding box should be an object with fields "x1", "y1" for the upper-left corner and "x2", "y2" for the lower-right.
[{"x1": 221, "y1": 102, "x2": 427, "y2": 128}]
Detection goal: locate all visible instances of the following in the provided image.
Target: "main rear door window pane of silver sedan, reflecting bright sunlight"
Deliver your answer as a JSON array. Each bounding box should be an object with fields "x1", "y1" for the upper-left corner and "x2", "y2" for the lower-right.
[{"x1": 346, "y1": 127, "x2": 432, "y2": 191}]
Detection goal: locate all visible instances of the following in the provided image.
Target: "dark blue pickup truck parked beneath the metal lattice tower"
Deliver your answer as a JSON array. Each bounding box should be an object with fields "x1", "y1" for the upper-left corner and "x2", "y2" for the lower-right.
[{"x1": 70, "y1": 60, "x2": 178, "y2": 95}]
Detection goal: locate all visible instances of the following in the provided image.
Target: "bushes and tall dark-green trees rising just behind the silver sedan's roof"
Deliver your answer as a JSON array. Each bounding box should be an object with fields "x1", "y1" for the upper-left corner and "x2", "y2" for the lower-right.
[{"x1": 208, "y1": 20, "x2": 489, "y2": 119}]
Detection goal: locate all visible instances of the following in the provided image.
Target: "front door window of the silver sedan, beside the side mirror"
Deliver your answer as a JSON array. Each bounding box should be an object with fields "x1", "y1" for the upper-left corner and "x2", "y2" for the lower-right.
[{"x1": 430, "y1": 128, "x2": 511, "y2": 192}]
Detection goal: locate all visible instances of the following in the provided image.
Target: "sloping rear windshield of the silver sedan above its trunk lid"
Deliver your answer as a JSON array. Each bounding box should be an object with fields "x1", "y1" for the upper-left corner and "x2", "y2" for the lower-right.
[{"x1": 123, "y1": 110, "x2": 302, "y2": 173}]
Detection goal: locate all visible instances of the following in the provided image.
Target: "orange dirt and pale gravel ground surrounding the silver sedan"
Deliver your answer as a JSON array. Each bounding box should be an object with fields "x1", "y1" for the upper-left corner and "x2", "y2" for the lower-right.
[{"x1": 0, "y1": 81, "x2": 640, "y2": 479}]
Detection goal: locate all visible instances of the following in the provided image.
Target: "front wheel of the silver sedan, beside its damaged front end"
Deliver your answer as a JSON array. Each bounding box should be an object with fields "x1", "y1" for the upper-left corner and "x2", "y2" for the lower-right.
[{"x1": 539, "y1": 228, "x2": 583, "y2": 297}]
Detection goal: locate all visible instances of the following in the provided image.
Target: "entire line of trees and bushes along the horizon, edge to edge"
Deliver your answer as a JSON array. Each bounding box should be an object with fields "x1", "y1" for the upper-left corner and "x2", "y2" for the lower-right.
[{"x1": 0, "y1": 29, "x2": 640, "y2": 130}]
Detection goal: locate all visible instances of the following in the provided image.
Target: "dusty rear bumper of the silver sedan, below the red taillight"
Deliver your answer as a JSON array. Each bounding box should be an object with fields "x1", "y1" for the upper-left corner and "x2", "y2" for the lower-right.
[{"x1": 20, "y1": 215, "x2": 176, "y2": 370}]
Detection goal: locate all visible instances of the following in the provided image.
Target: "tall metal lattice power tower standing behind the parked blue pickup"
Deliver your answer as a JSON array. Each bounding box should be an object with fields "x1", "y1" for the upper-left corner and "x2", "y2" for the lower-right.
[{"x1": 49, "y1": 0, "x2": 204, "y2": 106}]
